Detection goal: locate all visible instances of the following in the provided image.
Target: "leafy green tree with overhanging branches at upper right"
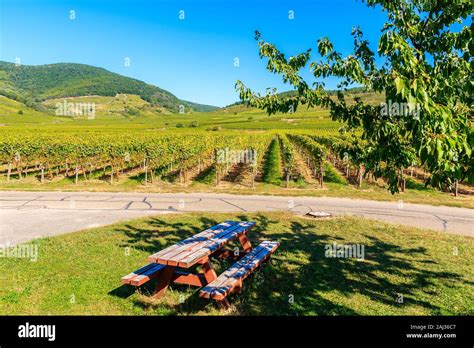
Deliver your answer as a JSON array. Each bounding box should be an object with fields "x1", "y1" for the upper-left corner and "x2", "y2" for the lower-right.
[{"x1": 236, "y1": 0, "x2": 474, "y2": 193}]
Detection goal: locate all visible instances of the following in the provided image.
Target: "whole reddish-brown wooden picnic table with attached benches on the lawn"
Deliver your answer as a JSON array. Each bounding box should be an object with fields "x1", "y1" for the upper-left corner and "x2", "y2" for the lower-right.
[{"x1": 122, "y1": 221, "x2": 279, "y2": 307}]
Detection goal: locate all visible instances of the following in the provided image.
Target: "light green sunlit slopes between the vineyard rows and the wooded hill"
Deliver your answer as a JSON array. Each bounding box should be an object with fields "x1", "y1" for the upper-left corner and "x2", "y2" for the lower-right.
[{"x1": 0, "y1": 94, "x2": 340, "y2": 132}]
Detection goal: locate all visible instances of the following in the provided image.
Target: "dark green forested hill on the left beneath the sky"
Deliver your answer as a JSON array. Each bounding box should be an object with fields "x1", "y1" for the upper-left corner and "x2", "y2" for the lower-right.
[{"x1": 0, "y1": 62, "x2": 217, "y2": 112}]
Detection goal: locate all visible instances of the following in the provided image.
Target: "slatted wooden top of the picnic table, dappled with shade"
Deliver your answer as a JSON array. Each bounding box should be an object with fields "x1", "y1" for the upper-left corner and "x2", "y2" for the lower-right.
[{"x1": 148, "y1": 221, "x2": 255, "y2": 268}]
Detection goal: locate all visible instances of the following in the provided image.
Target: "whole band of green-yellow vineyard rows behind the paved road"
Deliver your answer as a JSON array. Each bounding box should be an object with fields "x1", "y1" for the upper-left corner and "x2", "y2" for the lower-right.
[{"x1": 0, "y1": 129, "x2": 470, "y2": 200}]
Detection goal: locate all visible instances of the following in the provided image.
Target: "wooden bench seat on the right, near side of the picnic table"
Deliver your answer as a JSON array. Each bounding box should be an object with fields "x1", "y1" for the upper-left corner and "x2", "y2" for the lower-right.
[{"x1": 199, "y1": 241, "x2": 280, "y2": 304}]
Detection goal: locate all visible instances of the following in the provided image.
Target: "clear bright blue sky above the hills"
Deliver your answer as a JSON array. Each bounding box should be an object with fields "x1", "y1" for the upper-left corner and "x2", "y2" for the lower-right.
[{"x1": 0, "y1": 0, "x2": 385, "y2": 106}]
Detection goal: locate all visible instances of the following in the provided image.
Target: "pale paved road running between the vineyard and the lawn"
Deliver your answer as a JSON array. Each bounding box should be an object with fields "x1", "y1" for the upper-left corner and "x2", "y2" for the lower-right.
[{"x1": 0, "y1": 191, "x2": 474, "y2": 245}]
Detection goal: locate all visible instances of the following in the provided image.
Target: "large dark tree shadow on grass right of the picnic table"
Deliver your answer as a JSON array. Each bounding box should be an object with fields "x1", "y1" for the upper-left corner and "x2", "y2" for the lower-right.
[{"x1": 235, "y1": 222, "x2": 462, "y2": 315}]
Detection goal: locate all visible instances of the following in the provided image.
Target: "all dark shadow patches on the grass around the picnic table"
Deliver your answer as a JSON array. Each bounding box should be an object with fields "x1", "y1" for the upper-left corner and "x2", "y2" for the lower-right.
[{"x1": 113, "y1": 214, "x2": 464, "y2": 315}]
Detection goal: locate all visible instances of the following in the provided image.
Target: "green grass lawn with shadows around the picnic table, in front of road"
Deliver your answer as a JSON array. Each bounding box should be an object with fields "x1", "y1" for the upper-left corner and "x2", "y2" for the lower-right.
[{"x1": 0, "y1": 212, "x2": 474, "y2": 315}]
